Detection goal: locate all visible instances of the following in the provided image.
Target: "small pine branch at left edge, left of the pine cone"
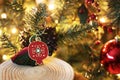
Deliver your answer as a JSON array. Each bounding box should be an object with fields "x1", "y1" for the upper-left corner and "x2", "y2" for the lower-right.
[{"x1": 0, "y1": 33, "x2": 17, "y2": 53}]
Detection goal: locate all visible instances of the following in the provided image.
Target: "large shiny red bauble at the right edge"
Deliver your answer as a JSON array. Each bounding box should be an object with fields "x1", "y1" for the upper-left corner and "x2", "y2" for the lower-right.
[{"x1": 101, "y1": 39, "x2": 120, "y2": 74}]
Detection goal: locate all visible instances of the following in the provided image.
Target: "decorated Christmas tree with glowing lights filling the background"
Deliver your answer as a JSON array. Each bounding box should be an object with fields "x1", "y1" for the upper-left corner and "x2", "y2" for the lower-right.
[{"x1": 0, "y1": 0, "x2": 120, "y2": 80}]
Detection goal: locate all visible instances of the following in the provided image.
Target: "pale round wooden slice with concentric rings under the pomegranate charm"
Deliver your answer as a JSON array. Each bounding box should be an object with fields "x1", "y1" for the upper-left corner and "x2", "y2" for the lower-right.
[{"x1": 0, "y1": 57, "x2": 74, "y2": 80}]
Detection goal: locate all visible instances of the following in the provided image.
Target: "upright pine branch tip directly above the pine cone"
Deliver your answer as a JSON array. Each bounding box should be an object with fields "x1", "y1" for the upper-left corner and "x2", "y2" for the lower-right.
[{"x1": 24, "y1": 4, "x2": 46, "y2": 32}]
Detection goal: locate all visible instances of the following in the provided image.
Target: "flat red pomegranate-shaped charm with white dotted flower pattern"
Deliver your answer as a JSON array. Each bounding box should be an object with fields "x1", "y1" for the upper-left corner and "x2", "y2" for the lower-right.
[{"x1": 28, "y1": 41, "x2": 49, "y2": 64}]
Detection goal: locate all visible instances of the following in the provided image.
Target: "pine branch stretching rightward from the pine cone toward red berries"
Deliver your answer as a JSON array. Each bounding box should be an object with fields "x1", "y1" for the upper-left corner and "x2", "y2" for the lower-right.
[{"x1": 58, "y1": 23, "x2": 98, "y2": 43}]
